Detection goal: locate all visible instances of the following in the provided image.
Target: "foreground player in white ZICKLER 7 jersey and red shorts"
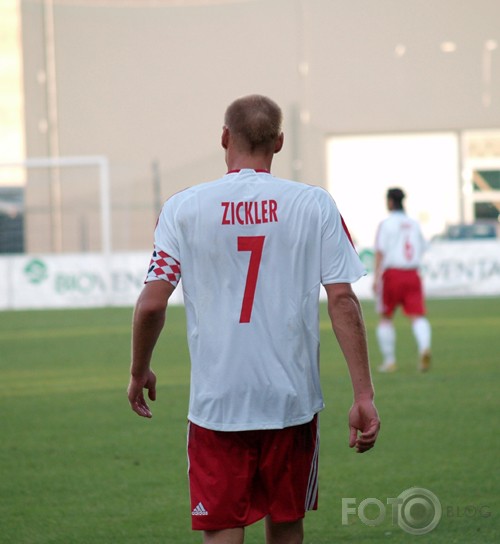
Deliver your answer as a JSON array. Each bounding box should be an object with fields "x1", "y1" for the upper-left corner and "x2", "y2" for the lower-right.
[{"x1": 128, "y1": 95, "x2": 380, "y2": 544}]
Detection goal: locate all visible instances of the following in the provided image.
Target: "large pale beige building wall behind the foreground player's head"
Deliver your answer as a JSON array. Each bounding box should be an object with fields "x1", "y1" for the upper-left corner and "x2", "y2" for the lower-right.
[{"x1": 21, "y1": 0, "x2": 500, "y2": 250}]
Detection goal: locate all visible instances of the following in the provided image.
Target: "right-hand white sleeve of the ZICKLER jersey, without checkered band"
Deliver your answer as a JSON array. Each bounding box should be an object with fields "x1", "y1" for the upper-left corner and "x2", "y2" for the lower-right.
[{"x1": 319, "y1": 190, "x2": 366, "y2": 285}]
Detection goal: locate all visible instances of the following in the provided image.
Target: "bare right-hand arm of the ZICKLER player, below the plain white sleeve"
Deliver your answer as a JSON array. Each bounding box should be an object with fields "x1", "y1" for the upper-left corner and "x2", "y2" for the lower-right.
[{"x1": 325, "y1": 283, "x2": 380, "y2": 453}]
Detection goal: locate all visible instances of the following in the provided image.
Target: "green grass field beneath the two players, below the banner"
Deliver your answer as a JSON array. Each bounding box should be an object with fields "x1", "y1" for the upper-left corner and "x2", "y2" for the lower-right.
[{"x1": 0, "y1": 298, "x2": 500, "y2": 544}]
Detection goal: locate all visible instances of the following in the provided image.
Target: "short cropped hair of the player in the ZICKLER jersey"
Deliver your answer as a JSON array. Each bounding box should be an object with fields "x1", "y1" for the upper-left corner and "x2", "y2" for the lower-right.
[{"x1": 224, "y1": 94, "x2": 283, "y2": 153}]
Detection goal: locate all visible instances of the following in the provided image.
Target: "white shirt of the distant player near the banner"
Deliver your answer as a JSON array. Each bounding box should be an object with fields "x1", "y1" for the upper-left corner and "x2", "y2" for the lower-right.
[{"x1": 375, "y1": 210, "x2": 426, "y2": 270}]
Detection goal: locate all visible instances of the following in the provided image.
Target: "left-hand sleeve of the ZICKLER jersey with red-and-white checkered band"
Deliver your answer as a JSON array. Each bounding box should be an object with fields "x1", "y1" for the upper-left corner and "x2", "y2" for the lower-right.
[{"x1": 144, "y1": 201, "x2": 181, "y2": 287}]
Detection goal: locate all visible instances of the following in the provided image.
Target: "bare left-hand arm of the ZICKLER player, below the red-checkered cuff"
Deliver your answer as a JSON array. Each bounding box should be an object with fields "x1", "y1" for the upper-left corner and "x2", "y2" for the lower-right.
[{"x1": 128, "y1": 280, "x2": 175, "y2": 417}]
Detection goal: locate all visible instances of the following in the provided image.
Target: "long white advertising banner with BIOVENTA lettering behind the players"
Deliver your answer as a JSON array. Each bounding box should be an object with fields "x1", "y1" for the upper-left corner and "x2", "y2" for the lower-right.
[{"x1": 0, "y1": 240, "x2": 500, "y2": 310}]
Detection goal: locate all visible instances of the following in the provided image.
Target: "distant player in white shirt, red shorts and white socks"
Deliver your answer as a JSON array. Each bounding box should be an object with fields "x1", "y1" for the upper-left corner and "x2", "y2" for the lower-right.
[{"x1": 373, "y1": 187, "x2": 431, "y2": 372}]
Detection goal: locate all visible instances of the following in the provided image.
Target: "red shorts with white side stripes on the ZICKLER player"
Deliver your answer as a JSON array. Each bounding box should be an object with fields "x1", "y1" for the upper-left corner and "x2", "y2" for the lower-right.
[{"x1": 188, "y1": 415, "x2": 319, "y2": 531}]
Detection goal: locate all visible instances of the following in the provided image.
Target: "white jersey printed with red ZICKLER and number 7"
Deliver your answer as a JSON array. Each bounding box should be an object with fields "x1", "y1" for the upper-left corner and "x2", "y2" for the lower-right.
[{"x1": 146, "y1": 169, "x2": 365, "y2": 431}]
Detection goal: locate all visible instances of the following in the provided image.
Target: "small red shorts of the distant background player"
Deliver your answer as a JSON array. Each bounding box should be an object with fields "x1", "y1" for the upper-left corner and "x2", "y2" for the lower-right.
[{"x1": 378, "y1": 268, "x2": 425, "y2": 317}]
